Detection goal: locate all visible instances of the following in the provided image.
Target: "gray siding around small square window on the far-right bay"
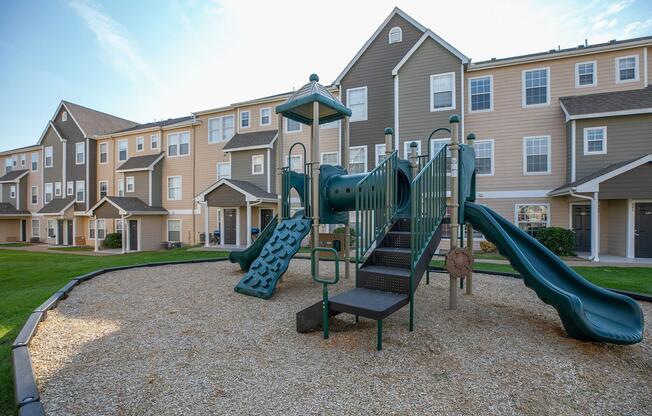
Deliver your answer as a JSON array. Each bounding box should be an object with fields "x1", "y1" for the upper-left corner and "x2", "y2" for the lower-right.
[{"x1": 575, "y1": 114, "x2": 652, "y2": 179}]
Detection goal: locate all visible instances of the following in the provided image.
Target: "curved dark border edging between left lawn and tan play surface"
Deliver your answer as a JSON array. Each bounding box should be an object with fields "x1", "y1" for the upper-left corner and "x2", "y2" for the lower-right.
[{"x1": 11, "y1": 257, "x2": 229, "y2": 416}]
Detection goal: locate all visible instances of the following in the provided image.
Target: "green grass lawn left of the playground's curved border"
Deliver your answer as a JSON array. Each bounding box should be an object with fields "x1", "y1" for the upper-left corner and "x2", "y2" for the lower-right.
[{"x1": 0, "y1": 247, "x2": 228, "y2": 416}]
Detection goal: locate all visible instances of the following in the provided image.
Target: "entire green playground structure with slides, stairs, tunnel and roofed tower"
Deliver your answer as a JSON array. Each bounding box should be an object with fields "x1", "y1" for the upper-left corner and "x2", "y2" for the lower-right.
[{"x1": 231, "y1": 74, "x2": 643, "y2": 350}]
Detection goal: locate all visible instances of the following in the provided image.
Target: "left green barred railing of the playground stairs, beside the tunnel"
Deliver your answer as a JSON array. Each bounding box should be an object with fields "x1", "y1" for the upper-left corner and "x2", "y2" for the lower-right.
[{"x1": 355, "y1": 151, "x2": 398, "y2": 276}]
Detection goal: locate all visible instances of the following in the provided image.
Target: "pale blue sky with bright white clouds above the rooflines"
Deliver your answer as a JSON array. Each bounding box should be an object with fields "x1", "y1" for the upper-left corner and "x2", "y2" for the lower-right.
[{"x1": 0, "y1": 0, "x2": 652, "y2": 150}]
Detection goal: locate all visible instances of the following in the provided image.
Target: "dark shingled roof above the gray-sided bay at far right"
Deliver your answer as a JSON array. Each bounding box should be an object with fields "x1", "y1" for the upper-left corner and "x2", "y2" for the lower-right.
[{"x1": 559, "y1": 87, "x2": 652, "y2": 121}]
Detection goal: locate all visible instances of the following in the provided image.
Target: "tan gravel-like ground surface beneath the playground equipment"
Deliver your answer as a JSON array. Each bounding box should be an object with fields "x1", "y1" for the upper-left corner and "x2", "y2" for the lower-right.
[{"x1": 30, "y1": 260, "x2": 652, "y2": 415}]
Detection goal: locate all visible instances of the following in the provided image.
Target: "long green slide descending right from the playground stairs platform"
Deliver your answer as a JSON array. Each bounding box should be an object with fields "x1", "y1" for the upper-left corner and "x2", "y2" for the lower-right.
[{"x1": 464, "y1": 201, "x2": 643, "y2": 344}]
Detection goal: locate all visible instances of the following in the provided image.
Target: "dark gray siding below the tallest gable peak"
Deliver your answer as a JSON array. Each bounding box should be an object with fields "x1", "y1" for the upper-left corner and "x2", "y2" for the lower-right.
[{"x1": 340, "y1": 15, "x2": 423, "y2": 167}]
